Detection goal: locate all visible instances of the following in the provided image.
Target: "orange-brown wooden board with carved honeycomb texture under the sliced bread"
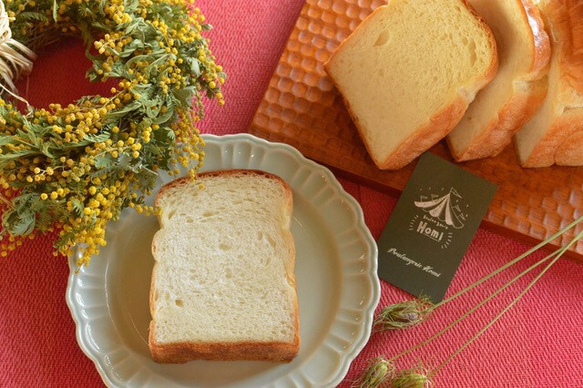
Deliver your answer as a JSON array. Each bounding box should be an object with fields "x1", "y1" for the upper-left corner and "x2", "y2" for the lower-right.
[{"x1": 249, "y1": 0, "x2": 583, "y2": 261}]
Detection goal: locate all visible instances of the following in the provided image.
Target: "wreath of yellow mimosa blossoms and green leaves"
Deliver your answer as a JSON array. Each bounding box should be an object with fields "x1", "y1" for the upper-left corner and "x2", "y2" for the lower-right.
[{"x1": 0, "y1": 0, "x2": 225, "y2": 266}]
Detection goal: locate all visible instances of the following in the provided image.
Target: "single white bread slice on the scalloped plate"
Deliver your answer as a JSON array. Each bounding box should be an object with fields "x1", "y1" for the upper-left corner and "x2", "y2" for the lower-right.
[{"x1": 149, "y1": 170, "x2": 300, "y2": 363}]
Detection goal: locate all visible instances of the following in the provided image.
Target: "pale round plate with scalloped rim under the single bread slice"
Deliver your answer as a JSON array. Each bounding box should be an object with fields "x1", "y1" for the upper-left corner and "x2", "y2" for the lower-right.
[{"x1": 67, "y1": 134, "x2": 380, "y2": 387}]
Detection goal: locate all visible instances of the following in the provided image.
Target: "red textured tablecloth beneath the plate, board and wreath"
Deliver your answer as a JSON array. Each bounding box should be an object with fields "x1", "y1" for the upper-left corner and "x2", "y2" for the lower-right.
[{"x1": 0, "y1": 0, "x2": 583, "y2": 388}]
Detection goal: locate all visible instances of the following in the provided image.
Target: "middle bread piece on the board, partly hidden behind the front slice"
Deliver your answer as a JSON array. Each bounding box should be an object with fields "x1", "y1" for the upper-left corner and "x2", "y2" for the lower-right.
[{"x1": 447, "y1": 0, "x2": 551, "y2": 161}]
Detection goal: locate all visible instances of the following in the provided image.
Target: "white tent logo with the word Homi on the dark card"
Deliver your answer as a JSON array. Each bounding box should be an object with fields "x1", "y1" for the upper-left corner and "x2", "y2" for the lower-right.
[{"x1": 409, "y1": 187, "x2": 469, "y2": 249}]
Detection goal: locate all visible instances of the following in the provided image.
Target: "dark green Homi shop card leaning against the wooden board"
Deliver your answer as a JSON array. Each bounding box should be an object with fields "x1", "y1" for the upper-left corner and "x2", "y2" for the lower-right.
[{"x1": 378, "y1": 152, "x2": 496, "y2": 303}]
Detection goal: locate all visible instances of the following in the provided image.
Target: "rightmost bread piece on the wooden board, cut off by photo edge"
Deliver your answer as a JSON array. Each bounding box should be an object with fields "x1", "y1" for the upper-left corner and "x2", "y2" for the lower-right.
[{"x1": 515, "y1": 0, "x2": 583, "y2": 167}]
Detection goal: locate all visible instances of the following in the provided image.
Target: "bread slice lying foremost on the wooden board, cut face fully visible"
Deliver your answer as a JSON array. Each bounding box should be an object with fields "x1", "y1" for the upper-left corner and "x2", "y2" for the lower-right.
[{"x1": 324, "y1": 0, "x2": 498, "y2": 170}]
